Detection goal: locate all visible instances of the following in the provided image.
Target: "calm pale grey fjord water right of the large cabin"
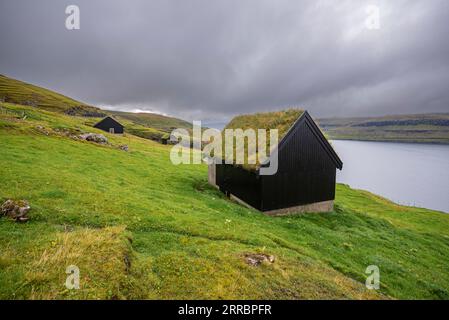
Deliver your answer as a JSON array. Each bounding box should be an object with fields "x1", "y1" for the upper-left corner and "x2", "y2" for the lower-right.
[{"x1": 331, "y1": 140, "x2": 449, "y2": 213}]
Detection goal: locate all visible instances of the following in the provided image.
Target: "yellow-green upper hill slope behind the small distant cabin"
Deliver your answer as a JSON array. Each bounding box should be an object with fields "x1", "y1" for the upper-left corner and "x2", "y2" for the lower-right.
[{"x1": 0, "y1": 75, "x2": 191, "y2": 141}]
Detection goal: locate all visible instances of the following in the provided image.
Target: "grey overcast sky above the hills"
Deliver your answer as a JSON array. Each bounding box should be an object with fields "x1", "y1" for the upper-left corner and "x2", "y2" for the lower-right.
[{"x1": 0, "y1": 0, "x2": 449, "y2": 121}]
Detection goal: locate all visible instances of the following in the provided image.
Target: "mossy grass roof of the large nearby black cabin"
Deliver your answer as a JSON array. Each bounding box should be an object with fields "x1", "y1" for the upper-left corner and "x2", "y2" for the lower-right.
[{"x1": 218, "y1": 108, "x2": 304, "y2": 170}]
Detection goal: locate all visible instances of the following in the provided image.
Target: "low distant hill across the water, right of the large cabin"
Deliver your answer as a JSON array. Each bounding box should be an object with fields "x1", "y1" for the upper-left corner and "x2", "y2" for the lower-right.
[{"x1": 317, "y1": 113, "x2": 449, "y2": 143}]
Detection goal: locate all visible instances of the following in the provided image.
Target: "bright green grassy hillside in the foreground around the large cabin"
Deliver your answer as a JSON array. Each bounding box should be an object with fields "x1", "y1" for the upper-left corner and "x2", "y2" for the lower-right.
[{"x1": 0, "y1": 103, "x2": 449, "y2": 299}]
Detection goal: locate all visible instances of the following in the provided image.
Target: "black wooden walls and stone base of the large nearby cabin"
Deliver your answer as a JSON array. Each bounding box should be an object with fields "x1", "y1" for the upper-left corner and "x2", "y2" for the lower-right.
[{"x1": 209, "y1": 111, "x2": 343, "y2": 215}]
